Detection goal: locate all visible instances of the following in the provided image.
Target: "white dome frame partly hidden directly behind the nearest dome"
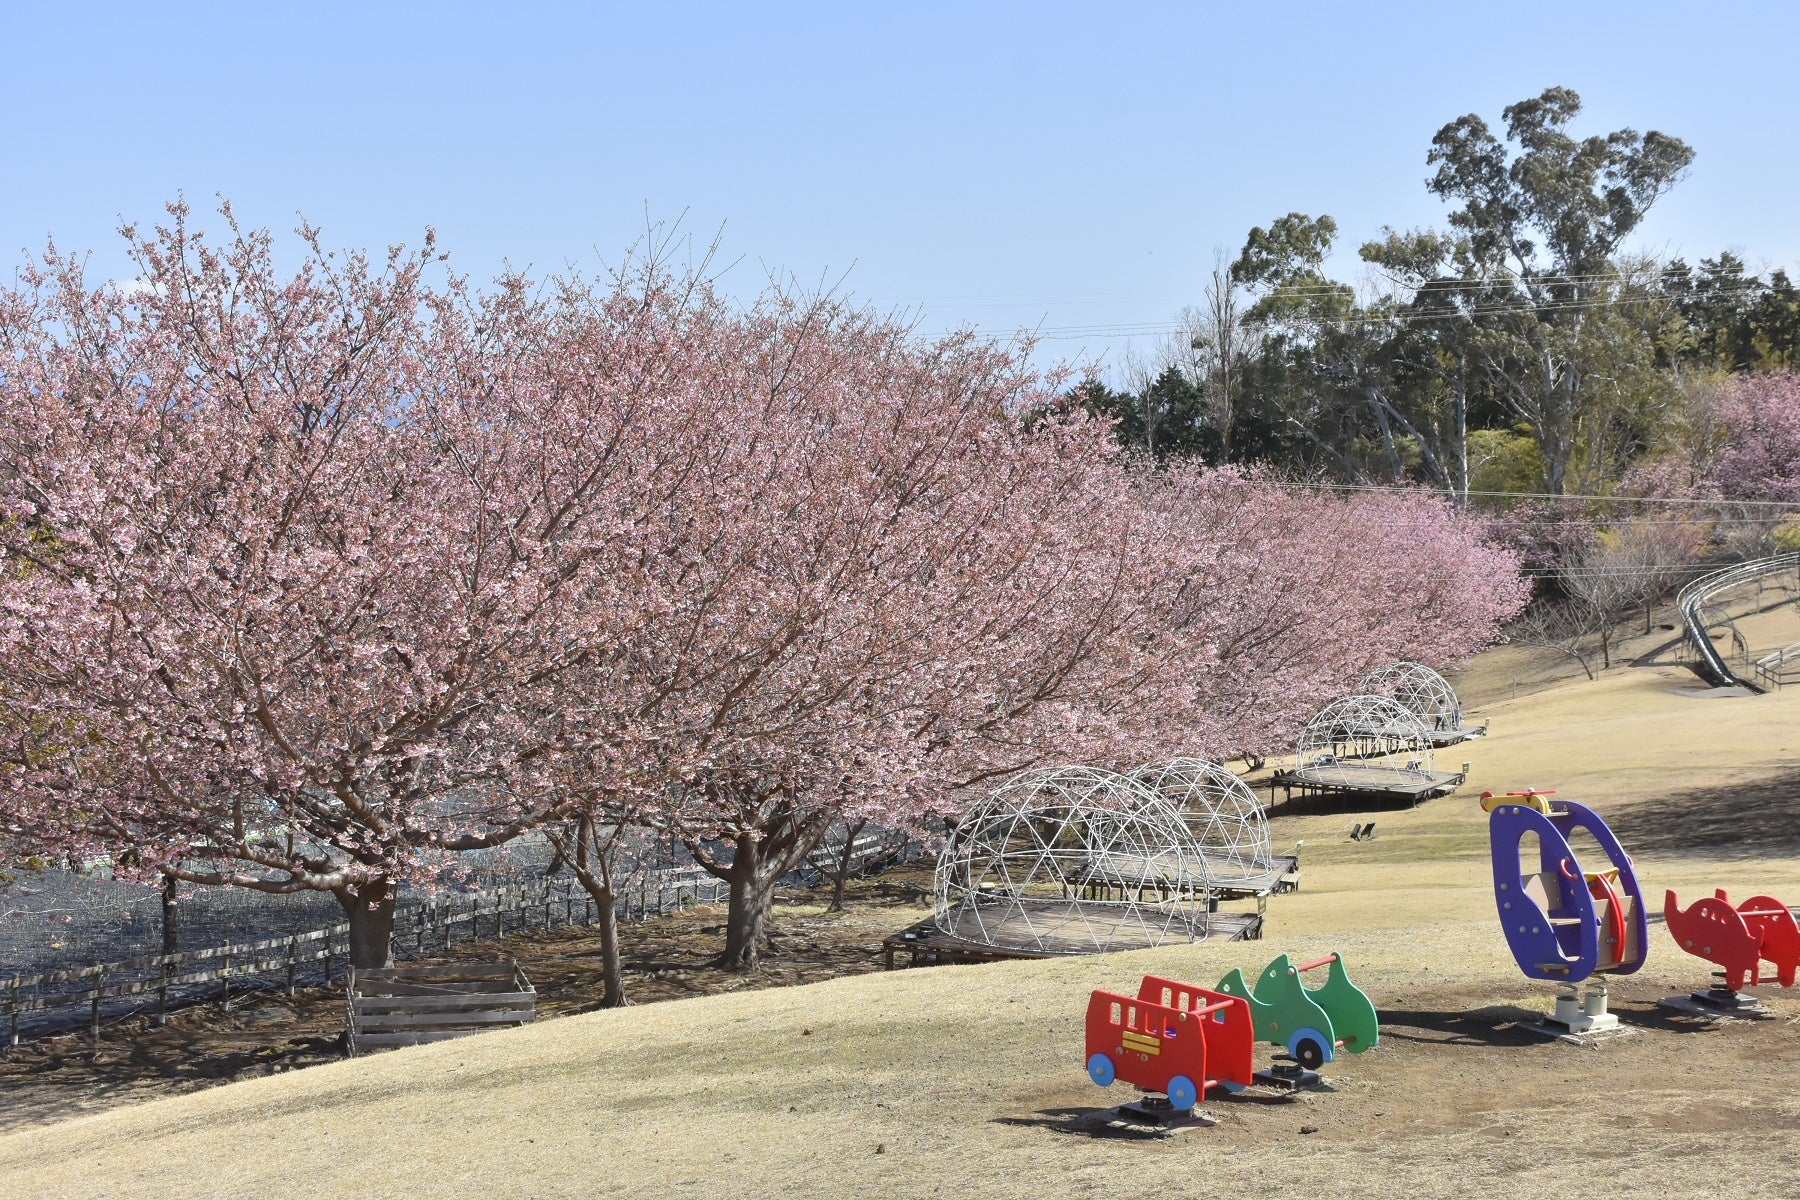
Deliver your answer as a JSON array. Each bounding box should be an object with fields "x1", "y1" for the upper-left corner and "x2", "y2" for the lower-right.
[{"x1": 1132, "y1": 757, "x2": 1291, "y2": 892}]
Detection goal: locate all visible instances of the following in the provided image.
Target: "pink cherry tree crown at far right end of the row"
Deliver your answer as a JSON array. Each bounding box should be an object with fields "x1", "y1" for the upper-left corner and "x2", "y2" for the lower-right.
[{"x1": 1152, "y1": 468, "x2": 1530, "y2": 757}]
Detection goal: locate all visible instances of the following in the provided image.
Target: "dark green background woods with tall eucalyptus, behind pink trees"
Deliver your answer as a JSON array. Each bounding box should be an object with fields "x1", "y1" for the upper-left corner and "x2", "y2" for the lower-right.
[{"x1": 1069, "y1": 88, "x2": 1800, "y2": 498}]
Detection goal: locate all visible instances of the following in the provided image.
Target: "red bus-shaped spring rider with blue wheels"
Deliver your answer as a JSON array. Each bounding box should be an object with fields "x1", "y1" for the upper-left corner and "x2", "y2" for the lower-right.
[{"x1": 1087, "y1": 975, "x2": 1251, "y2": 1114}]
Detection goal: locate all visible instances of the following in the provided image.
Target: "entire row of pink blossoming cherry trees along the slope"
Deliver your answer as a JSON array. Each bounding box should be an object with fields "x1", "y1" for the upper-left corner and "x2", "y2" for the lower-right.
[{"x1": 0, "y1": 205, "x2": 1525, "y2": 981}]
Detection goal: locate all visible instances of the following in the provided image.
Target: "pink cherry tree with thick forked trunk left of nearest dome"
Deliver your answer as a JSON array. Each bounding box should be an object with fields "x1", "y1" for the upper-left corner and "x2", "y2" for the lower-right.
[{"x1": 540, "y1": 297, "x2": 1206, "y2": 966}]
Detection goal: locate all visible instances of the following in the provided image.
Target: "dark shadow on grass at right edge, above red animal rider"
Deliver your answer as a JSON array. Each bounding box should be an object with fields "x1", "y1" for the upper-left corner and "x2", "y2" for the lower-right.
[{"x1": 1607, "y1": 768, "x2": 1800, "y2": 858}]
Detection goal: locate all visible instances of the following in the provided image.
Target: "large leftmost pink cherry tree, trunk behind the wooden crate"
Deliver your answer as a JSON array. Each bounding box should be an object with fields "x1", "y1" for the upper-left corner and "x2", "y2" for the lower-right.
[{"x1": 0, "y1": 205, "x2": 745, "y2": 966}]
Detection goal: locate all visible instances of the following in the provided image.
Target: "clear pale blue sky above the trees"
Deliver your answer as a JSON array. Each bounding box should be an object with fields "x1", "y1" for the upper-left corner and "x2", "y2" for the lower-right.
[{"x1": 0, "y1": 0, "x2": 1800, "y2": 379}]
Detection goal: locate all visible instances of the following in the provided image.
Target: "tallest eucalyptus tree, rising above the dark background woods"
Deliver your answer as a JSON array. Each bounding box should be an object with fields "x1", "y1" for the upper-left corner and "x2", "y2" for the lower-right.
[{"x1": 1363, "y1": 88, "x2": 1694, "y2": 495}]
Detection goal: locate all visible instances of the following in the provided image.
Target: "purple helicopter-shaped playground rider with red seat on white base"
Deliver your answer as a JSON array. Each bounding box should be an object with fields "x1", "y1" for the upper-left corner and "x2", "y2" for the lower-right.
[{"x1": 1481, "y1": 788, "x2": 1649, "y2": 1034}]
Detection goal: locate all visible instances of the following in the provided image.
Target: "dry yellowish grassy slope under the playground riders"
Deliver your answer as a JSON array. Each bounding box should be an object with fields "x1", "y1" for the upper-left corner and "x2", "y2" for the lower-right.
[{"x1": 0, "y1": 669, "x2": 1800, "y2": 1196}]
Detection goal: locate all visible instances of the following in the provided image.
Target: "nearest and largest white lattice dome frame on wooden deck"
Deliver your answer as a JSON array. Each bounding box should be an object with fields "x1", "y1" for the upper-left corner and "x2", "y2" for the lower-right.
[{"x1": 932, "y1": 766, "x2": 1211, "y2": 954}]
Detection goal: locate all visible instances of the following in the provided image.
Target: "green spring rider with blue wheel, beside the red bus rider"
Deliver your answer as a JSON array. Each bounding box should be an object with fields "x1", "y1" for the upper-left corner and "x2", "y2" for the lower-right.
[{"x1": 1219, "y1": 954, "x2": 1381, "y2": 1087}]
